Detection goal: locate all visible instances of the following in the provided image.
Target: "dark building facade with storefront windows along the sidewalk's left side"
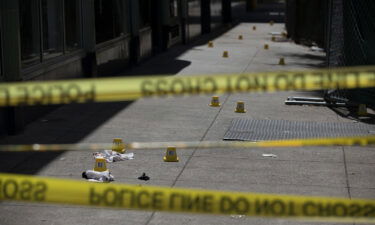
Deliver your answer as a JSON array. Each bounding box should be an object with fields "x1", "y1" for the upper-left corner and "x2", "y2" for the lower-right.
[{"x1": 0, "y1": 0, "x2": 234, "y2": 133}]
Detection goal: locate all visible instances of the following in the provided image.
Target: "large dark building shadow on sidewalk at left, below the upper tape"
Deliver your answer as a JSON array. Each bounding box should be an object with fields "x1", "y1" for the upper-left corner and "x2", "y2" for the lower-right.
[{"x1": 0, "y1": 102, "x2": 133, "y2": 174}]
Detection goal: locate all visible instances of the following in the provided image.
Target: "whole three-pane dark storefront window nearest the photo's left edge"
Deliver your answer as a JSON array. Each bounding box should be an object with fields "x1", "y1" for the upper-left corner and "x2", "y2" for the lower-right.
[{"x1": 19, "y1": 0, "x2": 81, "y2": 67}]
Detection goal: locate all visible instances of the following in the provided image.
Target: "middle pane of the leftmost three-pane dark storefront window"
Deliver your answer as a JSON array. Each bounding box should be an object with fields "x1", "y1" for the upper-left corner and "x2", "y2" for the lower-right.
[{"x1": 42, "y1": 0, "x2": 64, "y2": 59}]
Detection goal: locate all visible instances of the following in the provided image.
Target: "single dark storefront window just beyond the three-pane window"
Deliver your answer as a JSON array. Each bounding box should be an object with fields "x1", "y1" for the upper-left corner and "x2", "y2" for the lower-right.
[{"x1": 95, "y1": 0, "x2": 122, "y2": 43}]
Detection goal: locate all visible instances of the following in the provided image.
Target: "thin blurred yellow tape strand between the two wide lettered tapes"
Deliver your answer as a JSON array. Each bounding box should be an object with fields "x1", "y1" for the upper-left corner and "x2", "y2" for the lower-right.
[{"x1": 0, "y1": 135, "x2": 375, "y2": 152}]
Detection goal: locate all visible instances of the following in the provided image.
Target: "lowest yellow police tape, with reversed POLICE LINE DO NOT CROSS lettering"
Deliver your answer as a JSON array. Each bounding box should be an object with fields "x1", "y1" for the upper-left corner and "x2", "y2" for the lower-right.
[{"x1": 0, "y1": 174, "x2": 375, "y2": 222}]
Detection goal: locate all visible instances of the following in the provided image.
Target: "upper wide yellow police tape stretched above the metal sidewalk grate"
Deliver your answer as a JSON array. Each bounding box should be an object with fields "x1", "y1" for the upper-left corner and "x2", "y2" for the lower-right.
[{"x1": 0, "y1": 67, "x2": 375, "y2": 106}]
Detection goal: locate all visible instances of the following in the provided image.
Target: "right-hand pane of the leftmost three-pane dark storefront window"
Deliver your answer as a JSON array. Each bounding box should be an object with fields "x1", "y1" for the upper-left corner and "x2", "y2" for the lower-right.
[{"x1": 65, "y1": 0, "x2": 81, "y2": 52}]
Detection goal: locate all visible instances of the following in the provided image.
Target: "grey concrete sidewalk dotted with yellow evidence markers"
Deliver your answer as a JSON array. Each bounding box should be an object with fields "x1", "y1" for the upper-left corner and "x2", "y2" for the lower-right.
[{"x1": 0, "y1": 23, "x2": 375, "y2": 225}]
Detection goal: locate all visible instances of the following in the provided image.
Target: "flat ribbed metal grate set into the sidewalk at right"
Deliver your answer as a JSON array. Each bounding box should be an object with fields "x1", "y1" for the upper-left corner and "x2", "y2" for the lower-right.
[{"x1": 223, "y1": 119, "x2": 375, "y2": 141}]
